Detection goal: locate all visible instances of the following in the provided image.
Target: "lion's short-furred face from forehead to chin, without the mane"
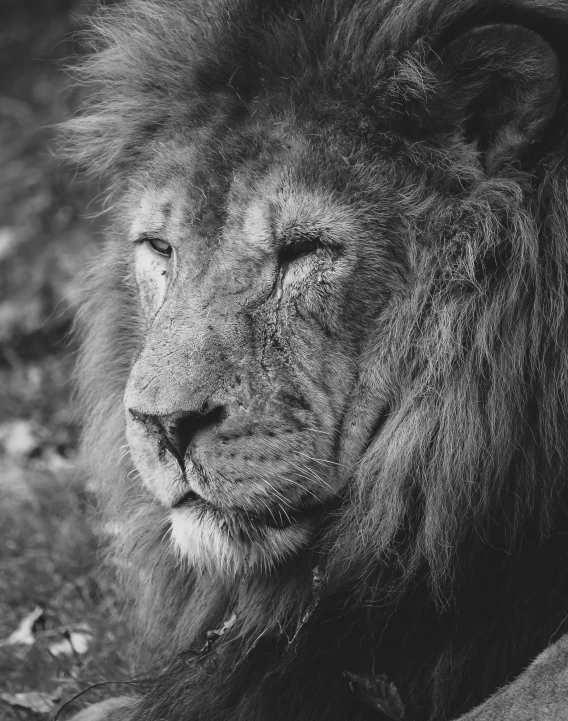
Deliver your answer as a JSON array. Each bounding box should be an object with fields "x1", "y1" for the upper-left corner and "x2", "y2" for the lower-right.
[{"x1": 125, "y1": 107, "x2": 404, "y2": 572}]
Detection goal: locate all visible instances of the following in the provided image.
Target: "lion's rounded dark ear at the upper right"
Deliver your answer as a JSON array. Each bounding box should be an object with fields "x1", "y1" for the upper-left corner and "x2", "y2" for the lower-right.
[{"x1": 438, "y1": 23, "x2": 561, "y2": 175}]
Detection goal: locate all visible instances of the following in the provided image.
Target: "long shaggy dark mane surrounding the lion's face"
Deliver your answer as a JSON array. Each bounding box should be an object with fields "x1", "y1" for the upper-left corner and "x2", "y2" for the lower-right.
[{"x1": 70, "y1": 0, "x2": 568, "y2": 721}]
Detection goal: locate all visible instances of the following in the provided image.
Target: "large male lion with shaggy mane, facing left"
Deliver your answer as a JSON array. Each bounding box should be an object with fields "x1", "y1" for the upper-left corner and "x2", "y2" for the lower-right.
[{"x1": 68, "y1": 0, "x2": 568, "y2": 721}]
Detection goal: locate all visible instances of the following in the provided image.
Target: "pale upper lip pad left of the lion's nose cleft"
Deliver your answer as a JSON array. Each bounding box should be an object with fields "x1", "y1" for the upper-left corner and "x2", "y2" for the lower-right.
[{"x1": 126, "y1": 420, "x2": 187, "y2": 508}]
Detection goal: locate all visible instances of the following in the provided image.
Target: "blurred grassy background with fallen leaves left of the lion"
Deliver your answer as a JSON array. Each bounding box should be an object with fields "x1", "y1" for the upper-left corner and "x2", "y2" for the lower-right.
[{"x1": 0, "y1": 0, "x2": 132, "y2": 721}]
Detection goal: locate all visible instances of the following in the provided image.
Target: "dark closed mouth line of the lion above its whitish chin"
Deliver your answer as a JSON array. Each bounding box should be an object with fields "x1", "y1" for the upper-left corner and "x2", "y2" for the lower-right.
[{"x1": 173, "y1": 491, "x2": 323, "y2": 533}]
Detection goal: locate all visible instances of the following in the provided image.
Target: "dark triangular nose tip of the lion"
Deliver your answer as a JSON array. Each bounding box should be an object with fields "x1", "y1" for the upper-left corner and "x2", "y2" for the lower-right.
[{"x1": 128, "y1": 407, "x2": 223, "y2": 471}]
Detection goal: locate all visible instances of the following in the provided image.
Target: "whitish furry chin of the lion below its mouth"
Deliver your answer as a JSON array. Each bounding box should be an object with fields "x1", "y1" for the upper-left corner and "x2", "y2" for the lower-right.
[{"x1": 170, "y1": 504, "x2": 312, "y2": 576}]
